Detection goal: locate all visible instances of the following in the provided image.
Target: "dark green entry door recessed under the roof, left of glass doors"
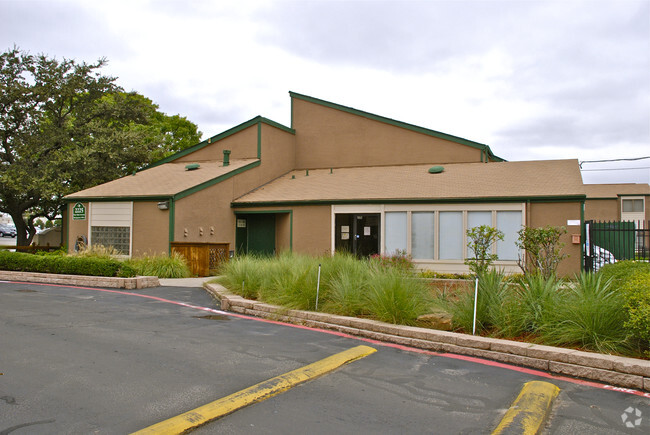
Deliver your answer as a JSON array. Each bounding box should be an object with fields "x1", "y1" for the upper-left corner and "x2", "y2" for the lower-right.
[{"x1": 235, "y1": 213, "x2": 275, "y2": 255}]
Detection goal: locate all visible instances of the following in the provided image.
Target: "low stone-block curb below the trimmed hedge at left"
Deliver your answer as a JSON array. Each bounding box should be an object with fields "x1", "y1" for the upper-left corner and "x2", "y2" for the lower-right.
[{"x1": 0, "y1": 270, "x2": 160, "y2": 290}]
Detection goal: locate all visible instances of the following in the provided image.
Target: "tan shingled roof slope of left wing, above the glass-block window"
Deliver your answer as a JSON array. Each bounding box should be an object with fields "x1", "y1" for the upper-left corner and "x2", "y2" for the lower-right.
[{"x1": 65, "y1": 159, "x2": 260, "y2": 201}]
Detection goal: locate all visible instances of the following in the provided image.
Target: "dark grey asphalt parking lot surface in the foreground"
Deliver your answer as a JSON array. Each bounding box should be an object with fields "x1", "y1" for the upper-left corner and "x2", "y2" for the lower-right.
[{"x1": 0, "y1": 283, "x2": 650, "y2": 435}]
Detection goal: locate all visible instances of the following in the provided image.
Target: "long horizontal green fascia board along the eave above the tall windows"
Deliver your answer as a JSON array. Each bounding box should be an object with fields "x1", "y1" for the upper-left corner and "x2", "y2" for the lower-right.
[{"x1": 230, "y1": 195, "x2": 585, "y2": 209}]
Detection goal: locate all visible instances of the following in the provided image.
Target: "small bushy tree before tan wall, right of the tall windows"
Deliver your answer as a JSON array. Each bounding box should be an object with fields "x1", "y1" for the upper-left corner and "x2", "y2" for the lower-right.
[{"x1": 516, "y1": 225, "x2": 567, "y2": 278}]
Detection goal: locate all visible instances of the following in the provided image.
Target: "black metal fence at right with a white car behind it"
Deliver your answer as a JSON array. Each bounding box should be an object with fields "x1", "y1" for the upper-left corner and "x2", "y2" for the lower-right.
[{"x1": 583, "y1": 221, "x2": 650, "y2": 272}]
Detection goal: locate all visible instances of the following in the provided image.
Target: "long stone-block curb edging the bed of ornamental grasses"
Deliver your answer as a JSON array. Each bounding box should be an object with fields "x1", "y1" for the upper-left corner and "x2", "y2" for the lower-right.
[{"x1": 204, "y1": 283, "x2": 650, "y2": 392}]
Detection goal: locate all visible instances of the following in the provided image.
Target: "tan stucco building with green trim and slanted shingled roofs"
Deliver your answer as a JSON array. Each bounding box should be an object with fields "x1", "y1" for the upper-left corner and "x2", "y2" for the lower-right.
[{"x1": 64, "y1": 92, "x2": 647, "y2": 274}]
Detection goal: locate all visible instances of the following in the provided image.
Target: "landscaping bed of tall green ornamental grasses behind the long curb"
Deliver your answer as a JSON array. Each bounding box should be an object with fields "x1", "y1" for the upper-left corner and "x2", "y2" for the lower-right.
[{"x1": 218, "y1": 254, "x2": 650, "y2": 359}]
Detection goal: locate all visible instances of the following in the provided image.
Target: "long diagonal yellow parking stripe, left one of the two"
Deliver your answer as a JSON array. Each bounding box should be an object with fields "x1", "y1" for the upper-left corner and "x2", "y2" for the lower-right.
[{"x1": 134, "y1": 346, "x2": 377, "y2": 435}]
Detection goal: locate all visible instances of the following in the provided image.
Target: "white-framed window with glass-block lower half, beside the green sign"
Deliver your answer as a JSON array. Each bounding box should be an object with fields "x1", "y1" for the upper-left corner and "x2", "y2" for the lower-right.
[{"x1": 88, "y1": 202, "x2": 133, "y2": 256}]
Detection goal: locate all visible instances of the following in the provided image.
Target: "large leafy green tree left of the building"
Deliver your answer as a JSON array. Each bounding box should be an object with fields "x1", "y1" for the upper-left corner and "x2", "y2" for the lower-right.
[{"x1": 0, "y1": 47, "x2": 201, "y2": 246}]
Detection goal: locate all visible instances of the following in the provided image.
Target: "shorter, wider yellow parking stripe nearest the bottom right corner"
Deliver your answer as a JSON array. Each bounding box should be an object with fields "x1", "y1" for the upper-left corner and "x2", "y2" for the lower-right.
[{"x1": 492, "y1": 381, "x2": 560, "y2": 435}]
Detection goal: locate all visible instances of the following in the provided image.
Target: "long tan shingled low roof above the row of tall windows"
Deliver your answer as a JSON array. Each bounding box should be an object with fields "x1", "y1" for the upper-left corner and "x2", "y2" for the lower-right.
[{"x1": 232, "y1": 160, "x2": 585, "y2": 207}]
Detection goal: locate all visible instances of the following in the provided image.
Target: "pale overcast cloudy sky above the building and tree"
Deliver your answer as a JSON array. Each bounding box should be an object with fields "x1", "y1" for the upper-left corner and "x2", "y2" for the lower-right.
[{"x1": 0, "y1": 0, "x2": 650, "y2": 183}]
